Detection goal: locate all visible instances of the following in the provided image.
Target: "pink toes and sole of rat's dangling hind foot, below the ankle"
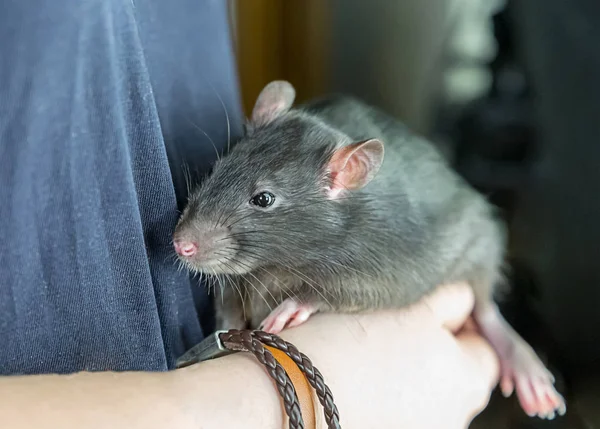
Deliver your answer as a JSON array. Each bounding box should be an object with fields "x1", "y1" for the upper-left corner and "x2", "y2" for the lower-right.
[{"x1": 500, "y1": 343, "x2": 567, "y2": 420}]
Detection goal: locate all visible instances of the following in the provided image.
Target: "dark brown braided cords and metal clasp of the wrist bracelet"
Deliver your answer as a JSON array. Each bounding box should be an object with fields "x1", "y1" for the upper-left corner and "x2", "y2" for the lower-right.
[{"x1": 177, "y1": 329, "x2": 341, "y2": 429}]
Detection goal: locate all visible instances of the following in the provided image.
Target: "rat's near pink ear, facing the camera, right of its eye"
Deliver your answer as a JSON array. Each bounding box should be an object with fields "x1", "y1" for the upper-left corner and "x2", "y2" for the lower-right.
[{"x1": 327, "y1": 139, "x2": 383, "y2": 199}]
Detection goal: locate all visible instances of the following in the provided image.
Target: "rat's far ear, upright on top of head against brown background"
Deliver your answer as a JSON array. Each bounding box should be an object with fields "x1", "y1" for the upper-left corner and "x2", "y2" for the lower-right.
[{"x1": 252, "y1": 80, "x2": 296, "y2": 125}]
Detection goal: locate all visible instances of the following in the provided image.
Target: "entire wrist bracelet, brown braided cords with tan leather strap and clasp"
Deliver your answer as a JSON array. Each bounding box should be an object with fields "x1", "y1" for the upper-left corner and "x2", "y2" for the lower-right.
[{"x1": 176, "y1": 329, "x2": 341, "y2": 429}]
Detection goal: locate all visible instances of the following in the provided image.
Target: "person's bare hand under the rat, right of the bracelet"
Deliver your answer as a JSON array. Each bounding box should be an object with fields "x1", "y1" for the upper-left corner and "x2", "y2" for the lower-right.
[{"x1": 281, "y1": 284, "x2": 499, "y2": 429}]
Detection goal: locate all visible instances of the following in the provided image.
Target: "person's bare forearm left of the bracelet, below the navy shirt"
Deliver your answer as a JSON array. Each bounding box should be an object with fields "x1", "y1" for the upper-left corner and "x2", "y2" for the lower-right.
[{"x1": 0, "y1": 354, "x2": 283, "y2": 429}]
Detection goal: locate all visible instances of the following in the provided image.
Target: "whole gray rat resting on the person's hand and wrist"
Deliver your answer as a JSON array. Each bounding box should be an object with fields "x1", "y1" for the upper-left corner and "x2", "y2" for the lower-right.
[{"x1": 174, "y1": 81, "x2": 566, "y2": 418}]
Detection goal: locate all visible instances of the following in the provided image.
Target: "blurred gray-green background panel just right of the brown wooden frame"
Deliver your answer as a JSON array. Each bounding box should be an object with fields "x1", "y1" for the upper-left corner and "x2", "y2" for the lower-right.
[{"x1": 327, "y1": 0, "x2": 454, "y2": 131}]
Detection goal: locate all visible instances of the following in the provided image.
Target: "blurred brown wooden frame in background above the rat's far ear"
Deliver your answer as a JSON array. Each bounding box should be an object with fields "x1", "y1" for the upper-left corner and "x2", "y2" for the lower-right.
[{"x1": 229, "y1": 0, "x2": 331, "y2": 116}]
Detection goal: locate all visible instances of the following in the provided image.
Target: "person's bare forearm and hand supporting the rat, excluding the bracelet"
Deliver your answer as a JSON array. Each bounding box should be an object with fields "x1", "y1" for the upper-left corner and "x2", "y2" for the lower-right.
[{"x1": 0, "y1": 285, "x2": 498, "y2": 429}]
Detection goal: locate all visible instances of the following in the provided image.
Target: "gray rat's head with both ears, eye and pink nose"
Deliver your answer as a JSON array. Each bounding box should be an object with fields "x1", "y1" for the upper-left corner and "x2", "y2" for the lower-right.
[{"x1": 174, "y1": 81, "x2": 383, "y2": 274}]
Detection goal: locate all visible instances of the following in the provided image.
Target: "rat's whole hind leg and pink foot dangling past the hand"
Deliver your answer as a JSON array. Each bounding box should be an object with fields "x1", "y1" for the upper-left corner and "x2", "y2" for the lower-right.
[{"x1": 475, "y1": 307, "x2": 567, "y2": 420}]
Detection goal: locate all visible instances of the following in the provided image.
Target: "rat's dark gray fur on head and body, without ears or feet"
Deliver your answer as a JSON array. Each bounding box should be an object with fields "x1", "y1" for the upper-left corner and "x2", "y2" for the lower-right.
[{"x1": 176, "y1": 96, "x2": 505, "y2": 328}]
